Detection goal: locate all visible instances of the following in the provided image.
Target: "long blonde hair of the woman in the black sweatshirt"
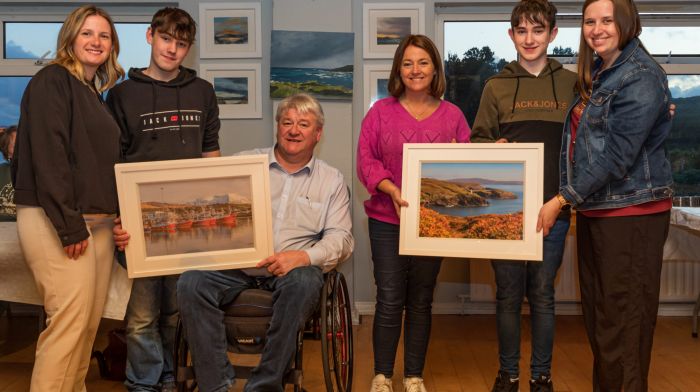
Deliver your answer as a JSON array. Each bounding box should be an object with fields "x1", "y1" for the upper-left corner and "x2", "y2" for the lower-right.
[{"x1": 52, "y1": 5, "x2": 124, "y2": 92}]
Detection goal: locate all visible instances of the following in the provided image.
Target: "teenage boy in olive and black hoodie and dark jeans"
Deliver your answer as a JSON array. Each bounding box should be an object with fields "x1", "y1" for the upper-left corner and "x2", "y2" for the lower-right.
[{"x1": 471, "y1": 0, "x2": 576, "y2": 392}]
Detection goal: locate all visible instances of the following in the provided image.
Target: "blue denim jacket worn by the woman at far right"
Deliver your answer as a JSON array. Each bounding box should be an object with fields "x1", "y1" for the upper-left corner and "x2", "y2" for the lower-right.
[{"x1": 559, "y1": 38, "x2": 672, "y2": 211}]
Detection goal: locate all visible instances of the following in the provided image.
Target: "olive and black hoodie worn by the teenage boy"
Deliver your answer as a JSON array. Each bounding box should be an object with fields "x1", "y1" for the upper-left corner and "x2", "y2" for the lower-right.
[{"x1": 471, "y1": 59, "x2": 576, "y2": 204}]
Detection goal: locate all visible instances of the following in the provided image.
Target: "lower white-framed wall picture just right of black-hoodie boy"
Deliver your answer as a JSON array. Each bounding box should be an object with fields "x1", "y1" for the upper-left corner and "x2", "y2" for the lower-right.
[{"x1": 199, "y1": 63, "x2": 262, "y2": 119}]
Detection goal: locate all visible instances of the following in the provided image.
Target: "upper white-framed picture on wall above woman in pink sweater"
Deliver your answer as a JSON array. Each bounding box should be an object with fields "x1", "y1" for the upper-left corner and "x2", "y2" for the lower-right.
[{"x1": 362, "y1": 3, "x2": 425, "y2": 59}]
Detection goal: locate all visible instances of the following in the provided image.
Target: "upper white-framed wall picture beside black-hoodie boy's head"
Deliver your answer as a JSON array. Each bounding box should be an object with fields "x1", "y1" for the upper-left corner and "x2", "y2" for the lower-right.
[{"x1": 199, "y1": 3, "x2": 262, "y2": 59}]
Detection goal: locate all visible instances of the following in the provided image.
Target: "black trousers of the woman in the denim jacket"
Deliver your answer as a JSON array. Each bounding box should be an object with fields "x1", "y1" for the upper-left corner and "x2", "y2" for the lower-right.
[{"x1": 576, "y1": 211, "x2": 670, "y2": 392}]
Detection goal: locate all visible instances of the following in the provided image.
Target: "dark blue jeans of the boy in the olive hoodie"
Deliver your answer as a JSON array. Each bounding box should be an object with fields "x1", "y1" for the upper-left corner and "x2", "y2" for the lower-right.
[{"x1": 491, "y1": 217, "x2": 569, "y2": 379}]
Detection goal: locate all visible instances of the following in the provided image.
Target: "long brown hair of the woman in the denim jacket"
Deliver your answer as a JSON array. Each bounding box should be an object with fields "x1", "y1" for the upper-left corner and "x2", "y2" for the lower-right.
[{"x1": 576, "y1": 0, "x2": 642, "y2": 102}]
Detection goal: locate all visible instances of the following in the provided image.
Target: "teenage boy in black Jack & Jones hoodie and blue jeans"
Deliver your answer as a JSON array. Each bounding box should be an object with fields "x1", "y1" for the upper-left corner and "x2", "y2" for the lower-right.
[{"x1": 107, "y1": 7, "x2": 221, "y2": 392}]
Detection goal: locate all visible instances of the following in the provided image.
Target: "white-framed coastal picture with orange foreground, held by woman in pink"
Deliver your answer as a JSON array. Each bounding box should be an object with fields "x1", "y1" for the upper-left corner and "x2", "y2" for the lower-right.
[{"x1": 399, "y1": 143, "x2": 544, "y2": 260}]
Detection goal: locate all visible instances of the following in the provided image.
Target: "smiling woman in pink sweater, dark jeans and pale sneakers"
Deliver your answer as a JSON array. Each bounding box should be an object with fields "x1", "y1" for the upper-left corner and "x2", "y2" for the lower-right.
[{"x1": 357, "y1": 35, "x2": 470, "y2": 391}]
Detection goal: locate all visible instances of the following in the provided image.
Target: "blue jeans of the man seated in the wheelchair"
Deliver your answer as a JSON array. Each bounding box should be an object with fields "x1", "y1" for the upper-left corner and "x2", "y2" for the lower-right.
[{"x1": 177, "y1": 266, "x2": 323, "y2": 392}]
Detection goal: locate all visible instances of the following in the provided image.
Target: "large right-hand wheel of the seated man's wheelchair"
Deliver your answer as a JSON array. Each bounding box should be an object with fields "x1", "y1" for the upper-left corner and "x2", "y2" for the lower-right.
[{"x1": 321, "y1": 271, "x2": 353, "y2": 392}]
